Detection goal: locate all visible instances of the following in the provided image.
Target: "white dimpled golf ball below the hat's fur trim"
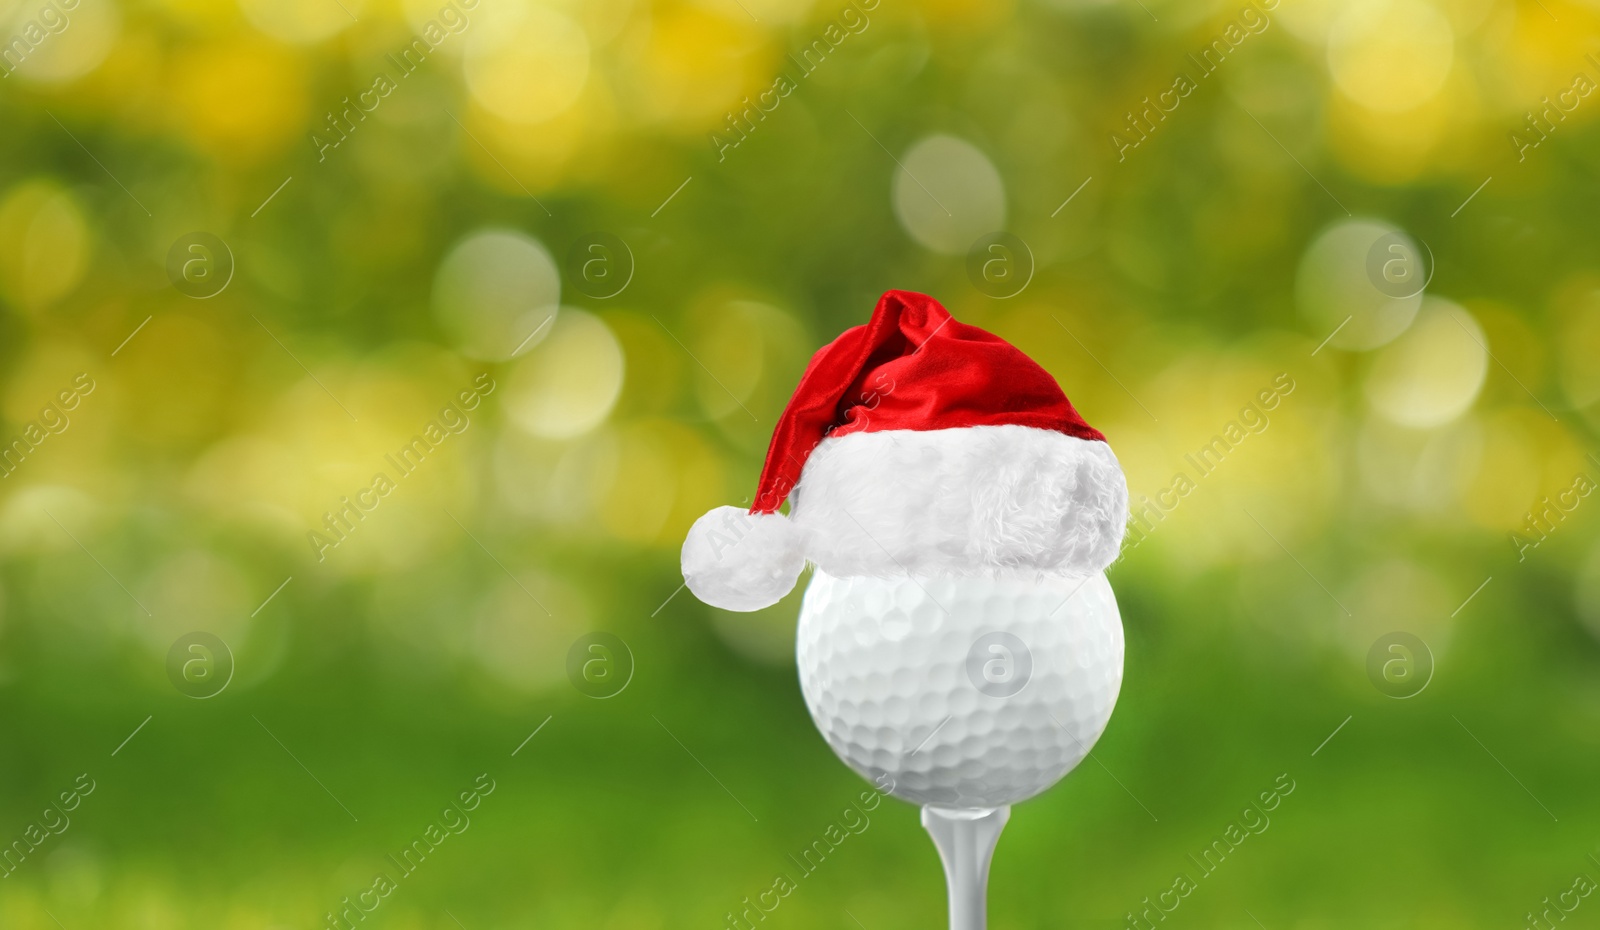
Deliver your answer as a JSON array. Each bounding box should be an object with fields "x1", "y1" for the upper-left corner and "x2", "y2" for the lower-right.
[{"x1": 795, "y1": 571, "x2": 1123, "y2": 808}]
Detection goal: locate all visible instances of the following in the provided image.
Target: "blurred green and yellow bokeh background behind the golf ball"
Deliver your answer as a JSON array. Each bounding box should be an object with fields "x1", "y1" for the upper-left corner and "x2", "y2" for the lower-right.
[{"x1": 0, "y1": 0, "x2": 1600, "y2": 930}]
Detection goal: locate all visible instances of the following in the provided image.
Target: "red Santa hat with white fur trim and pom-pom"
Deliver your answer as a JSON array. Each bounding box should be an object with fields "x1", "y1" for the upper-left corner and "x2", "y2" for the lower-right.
[{"x1": 683, "y1": 291, "x2": 1128, "y2": 610}]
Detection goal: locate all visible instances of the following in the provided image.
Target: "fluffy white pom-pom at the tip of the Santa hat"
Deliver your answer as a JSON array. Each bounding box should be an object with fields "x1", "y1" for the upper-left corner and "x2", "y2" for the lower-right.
[{"x1": 683, "y1": 507, "x2": 805, "y2": 611}]
